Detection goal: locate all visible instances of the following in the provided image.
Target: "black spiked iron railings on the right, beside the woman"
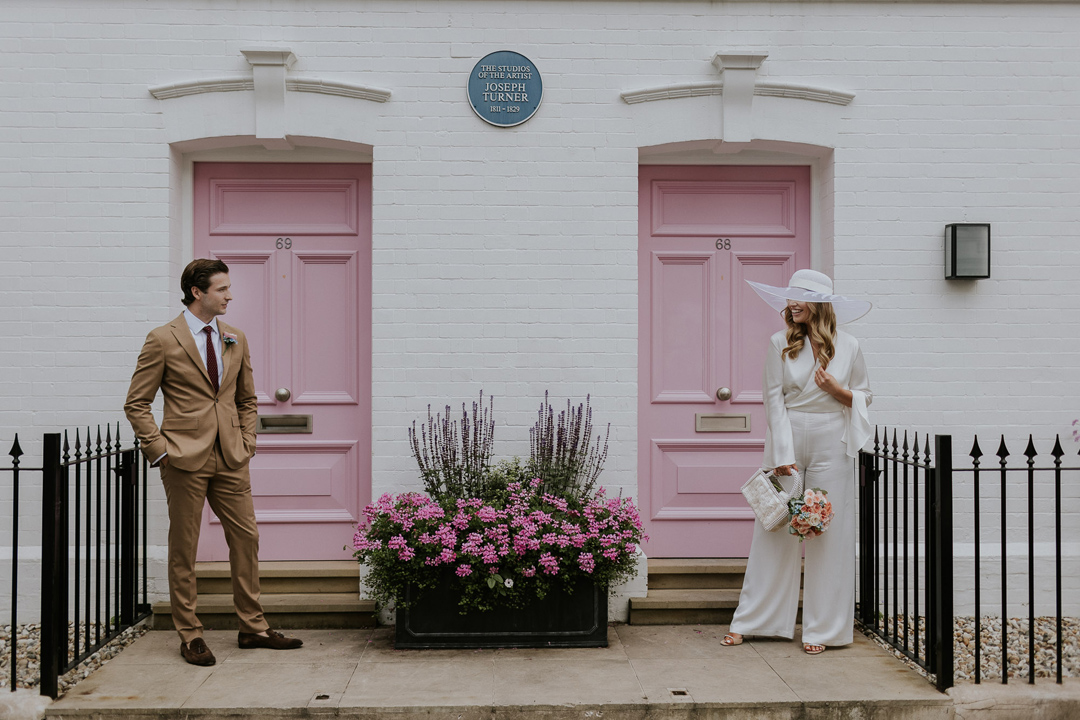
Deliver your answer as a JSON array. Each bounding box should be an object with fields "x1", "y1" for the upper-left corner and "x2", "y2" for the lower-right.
[{"x1": 856, "y1": 430, "x2": 1080, "y2": 690}]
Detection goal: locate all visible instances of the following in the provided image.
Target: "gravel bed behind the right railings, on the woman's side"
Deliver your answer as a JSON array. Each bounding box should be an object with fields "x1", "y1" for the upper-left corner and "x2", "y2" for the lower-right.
[{"x1": 863, "y1": 616, "x2": 1080, "y2": 684}]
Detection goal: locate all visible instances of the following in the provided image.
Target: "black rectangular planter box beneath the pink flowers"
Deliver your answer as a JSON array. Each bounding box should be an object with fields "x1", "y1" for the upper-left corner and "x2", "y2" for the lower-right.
[{"x1": 394, "y1": 579, "x2": 608, "y2": 649}]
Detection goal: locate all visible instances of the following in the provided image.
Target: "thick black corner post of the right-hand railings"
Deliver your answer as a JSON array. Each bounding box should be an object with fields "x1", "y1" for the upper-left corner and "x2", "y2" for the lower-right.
[{"x1": 928, "y1": 435, "x2": 955, "y2": 692}]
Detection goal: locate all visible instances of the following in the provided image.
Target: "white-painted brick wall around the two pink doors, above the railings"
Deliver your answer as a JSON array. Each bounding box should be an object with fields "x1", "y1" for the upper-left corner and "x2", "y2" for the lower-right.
[{"x1": 0, "y1": 0, "x2": 1080, "y2": 621}]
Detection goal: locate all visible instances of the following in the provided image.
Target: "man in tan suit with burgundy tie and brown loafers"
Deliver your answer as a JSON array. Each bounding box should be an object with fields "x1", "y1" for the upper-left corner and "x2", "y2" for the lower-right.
[{"x1": 124, "y1": 259, "x2": 303, "y2": 665}]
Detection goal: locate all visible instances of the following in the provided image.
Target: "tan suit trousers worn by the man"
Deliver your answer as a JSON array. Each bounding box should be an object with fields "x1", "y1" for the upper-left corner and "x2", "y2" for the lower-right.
[{"x1": 161, "y1": 444, "x2": 269, "y2": 642}]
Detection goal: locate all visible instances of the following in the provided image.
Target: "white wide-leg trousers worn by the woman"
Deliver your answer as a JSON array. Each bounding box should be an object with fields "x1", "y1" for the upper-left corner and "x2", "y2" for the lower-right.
[{"x1": 731, "y1": 410, "x2": 855, "y2": 647}]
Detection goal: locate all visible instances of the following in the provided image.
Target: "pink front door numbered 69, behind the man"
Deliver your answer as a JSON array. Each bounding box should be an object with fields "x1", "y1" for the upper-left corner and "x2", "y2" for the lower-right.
[{"x1": 194, "y1": 163, "x2": 372, "y2": 560}]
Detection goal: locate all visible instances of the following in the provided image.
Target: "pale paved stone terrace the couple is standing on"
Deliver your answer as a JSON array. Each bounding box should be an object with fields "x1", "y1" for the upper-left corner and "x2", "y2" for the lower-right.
[{"x1": 48, "y1": 625, "x2": 953, "y2": 720}]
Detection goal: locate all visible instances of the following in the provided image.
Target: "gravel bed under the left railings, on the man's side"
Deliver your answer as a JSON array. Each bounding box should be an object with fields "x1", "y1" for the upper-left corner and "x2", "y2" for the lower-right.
[{"x1": 0, "y1": 622, "x2": 150, "y2": 696}]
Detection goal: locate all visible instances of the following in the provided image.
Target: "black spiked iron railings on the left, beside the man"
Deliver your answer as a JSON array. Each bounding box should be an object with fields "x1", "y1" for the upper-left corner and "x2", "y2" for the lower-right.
[{"x1": 0, "y1": 424, "x2": 150, "y2": 697}]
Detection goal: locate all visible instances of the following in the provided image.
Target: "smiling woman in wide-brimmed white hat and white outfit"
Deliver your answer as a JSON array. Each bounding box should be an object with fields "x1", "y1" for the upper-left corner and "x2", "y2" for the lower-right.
[{"x1": 723, "y1": 270, "x2": 873, "y2": 655}]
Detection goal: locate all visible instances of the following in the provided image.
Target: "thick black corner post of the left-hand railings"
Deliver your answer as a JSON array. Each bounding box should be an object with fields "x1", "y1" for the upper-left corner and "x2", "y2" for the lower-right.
[{"x1": 40, "y1": 433, "x2": 68, "y2": 698}]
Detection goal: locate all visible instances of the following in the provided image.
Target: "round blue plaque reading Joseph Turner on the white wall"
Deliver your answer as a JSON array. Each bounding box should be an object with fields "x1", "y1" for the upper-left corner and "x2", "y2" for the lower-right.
[{"x1": 469, "y1": 50, "x2": 543, "y2": 127}]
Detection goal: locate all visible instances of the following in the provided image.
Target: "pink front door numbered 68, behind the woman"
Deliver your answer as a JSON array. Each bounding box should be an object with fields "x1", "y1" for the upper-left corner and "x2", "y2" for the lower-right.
[{"x1": 638, "y1": 165, "x2": 810, "y2": 557}]
